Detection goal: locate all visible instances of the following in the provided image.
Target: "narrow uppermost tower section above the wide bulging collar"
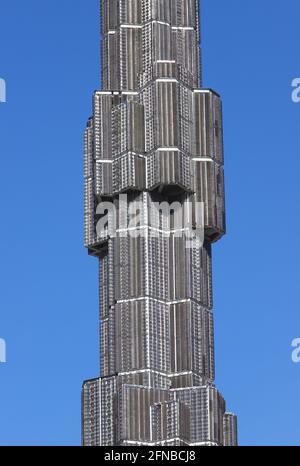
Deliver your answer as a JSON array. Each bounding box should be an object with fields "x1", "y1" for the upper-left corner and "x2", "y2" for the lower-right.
[{"x1": 101, "y1": 0, "x2": 201, "y2": 91}]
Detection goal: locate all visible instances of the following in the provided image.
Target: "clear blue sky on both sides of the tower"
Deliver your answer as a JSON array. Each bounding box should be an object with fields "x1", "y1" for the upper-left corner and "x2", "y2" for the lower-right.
[{"x1": 0, "y1": 0, "x2": 300, "y2": 445}]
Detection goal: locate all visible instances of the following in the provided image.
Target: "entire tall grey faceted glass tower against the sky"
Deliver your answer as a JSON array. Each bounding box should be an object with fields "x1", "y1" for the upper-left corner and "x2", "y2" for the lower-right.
[{"x1": 82, "y1": 0, "x2": 237, "y2": 446}]
